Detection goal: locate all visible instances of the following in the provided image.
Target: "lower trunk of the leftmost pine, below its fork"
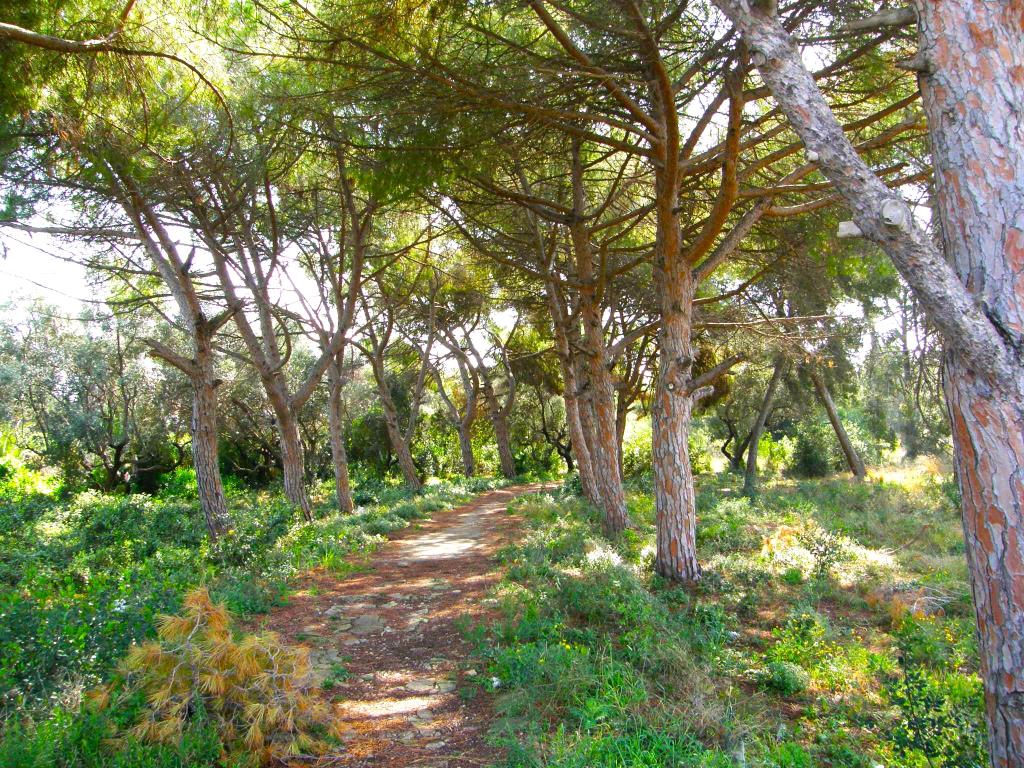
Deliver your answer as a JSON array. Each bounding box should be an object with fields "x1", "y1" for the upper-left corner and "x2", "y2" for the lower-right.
[{"x1": 191, "y1": 340, "x2": 228, "y2": 540}]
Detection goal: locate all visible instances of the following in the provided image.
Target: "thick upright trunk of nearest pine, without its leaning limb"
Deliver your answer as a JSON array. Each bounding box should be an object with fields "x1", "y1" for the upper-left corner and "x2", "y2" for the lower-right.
[{"x1": 914, "y1": 0, "x2": 1024, "y2": 768}]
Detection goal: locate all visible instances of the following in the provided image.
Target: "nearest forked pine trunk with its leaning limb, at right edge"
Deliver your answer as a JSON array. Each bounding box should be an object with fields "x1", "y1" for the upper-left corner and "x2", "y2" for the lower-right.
[{"x1": 715, "y1": 0, "x2": 1024, "y2": 768}]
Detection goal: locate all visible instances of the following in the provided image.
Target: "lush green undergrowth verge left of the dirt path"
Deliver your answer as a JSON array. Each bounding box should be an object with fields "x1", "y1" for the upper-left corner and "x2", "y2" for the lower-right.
[{"x1": 0, "y1": 478, "x2": 504, "y2": 768}]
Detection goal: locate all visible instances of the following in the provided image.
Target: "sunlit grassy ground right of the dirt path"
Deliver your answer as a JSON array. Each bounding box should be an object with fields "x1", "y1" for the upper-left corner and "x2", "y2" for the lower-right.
[{"x1": 475, "y1": 456, "x2": 986, "y2": 768}]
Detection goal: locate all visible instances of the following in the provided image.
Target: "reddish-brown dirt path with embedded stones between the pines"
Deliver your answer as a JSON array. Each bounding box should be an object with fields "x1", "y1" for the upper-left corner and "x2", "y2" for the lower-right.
[{"x1": 256, "y1": 484, "x2": 544, "y2": 768}]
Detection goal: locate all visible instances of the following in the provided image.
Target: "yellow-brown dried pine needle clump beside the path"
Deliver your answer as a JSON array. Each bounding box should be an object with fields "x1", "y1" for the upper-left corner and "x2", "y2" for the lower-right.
[{"x1": 91, "y1": 589, "x2": 326, "y2": 765}]
